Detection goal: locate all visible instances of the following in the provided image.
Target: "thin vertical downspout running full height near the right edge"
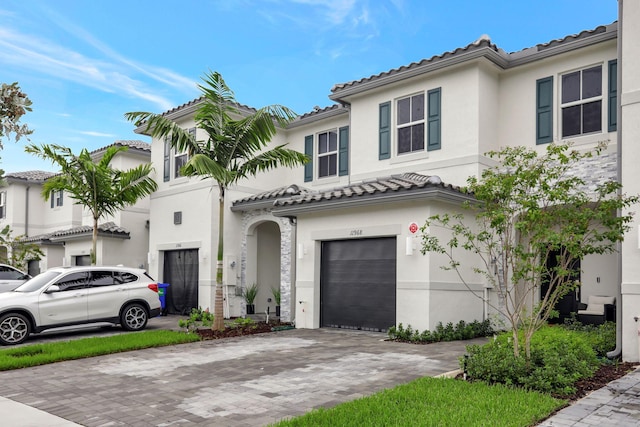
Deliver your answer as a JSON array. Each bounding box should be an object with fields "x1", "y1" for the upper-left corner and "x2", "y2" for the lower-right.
[{"x1": 607, "y1": 0, "x2": 623, "y2": 359}]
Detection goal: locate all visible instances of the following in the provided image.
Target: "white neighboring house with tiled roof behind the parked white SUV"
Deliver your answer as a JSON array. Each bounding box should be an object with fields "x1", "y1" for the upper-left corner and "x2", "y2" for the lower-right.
[{"x1": 0, "y1": 141, "x2": 151, "y2": 274}]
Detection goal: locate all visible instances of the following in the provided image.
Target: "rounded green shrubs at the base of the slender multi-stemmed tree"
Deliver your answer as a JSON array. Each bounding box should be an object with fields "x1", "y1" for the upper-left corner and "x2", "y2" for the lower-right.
[{"x1": 461, "y1": 327, "x2": 599, "y2": 396}]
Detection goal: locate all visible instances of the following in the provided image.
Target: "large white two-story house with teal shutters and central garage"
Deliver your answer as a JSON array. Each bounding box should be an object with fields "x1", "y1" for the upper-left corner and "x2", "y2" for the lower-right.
[{"x1": 136, "y1": 2, "x2": 640, "y2": 360}]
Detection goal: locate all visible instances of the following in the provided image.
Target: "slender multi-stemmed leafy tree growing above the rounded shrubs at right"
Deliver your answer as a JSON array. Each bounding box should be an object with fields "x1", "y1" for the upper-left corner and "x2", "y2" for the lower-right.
[{"x1": 421, "y1": 144, "x2": 638, "y2": 359}]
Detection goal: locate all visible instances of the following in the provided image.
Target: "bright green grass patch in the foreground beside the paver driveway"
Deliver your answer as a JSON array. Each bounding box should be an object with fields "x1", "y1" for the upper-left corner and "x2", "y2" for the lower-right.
[{"x1": 274, "y1": 377, "x2": 566, "y2": 427}]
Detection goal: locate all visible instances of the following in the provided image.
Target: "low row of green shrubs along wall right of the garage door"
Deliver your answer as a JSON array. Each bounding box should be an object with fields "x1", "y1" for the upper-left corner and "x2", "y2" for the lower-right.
[{"x1": 388, "y1": 320, "x2": 493, "y2": 344}]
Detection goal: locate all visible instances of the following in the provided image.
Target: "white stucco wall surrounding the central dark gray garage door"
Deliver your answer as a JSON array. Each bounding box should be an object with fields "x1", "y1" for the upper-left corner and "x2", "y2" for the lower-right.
[{"x1": 296, "y1": 202, "x2": 482, "y2": 330}]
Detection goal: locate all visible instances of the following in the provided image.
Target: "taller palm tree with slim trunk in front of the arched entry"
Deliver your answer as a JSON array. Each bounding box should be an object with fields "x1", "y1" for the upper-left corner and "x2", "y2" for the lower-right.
[{"x1": 125, "y1": 72, "x2": 307, "y2": 330}]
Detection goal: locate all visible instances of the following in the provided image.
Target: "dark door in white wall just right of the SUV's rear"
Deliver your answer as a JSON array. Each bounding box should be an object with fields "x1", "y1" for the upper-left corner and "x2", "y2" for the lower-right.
[{"x1": 163, "y1": 249, "x2": 198, "y2": 314}]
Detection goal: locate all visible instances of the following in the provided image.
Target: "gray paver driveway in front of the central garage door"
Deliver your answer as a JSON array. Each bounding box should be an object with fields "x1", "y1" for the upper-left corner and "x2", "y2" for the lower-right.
[{"x1": 0, "y1": 329, "x2": 486, "y2": 426}]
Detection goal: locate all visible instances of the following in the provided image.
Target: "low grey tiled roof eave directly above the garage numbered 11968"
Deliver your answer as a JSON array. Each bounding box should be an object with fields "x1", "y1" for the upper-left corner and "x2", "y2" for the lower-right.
[{"x1": 272, "y1": 187, "x2": 475, "y2": 217}]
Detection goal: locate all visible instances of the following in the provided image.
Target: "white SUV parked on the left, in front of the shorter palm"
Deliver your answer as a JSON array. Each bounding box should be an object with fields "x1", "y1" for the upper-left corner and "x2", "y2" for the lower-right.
[{"x1": 0, "y1": 266, "x2": 161, "y2": 345}]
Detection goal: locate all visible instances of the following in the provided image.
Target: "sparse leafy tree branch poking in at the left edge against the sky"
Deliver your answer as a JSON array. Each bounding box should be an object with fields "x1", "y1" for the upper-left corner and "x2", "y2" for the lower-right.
[{"x1": 0, "y1": 82, "x2": 33, "y2": 144}]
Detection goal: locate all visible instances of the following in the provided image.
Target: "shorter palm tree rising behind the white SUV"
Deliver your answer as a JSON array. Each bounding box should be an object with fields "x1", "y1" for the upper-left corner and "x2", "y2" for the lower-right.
[{"x1": 25, "y1": 144, "x2": 158, "y2": 265}]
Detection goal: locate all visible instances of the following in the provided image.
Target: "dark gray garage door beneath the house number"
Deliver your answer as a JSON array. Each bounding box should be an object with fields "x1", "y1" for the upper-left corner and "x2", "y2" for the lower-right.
[{"x1": 320, "y1": 237, "x2": 396, "y2": 331}]
